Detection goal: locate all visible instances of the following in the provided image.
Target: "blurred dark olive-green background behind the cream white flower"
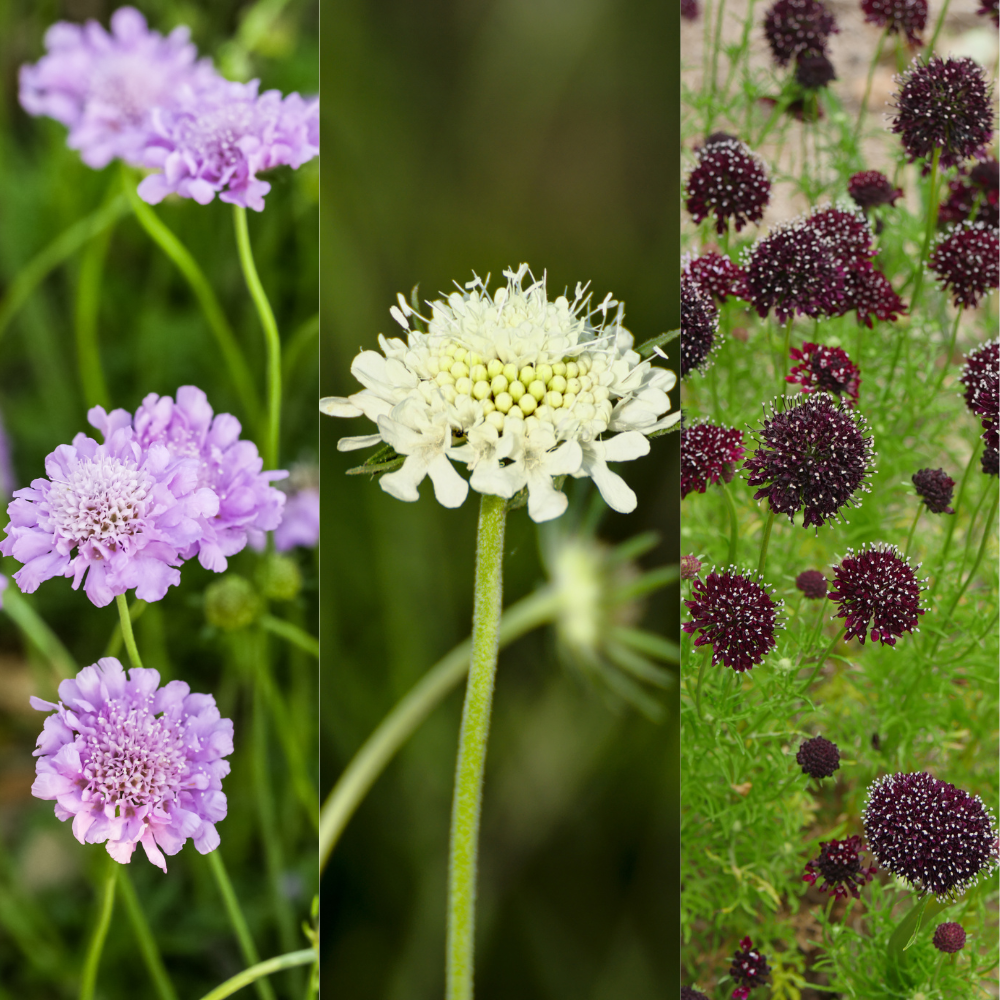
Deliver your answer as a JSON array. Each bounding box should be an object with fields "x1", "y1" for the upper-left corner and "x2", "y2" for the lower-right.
[{"x1": 320, "y1": 0, "x2": 680, "y2": 1000}]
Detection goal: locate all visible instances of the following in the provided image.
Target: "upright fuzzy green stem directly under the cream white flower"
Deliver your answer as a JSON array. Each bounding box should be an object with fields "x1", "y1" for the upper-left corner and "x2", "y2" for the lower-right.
[{"x1": 445, "y1": 494, "x2": 507, "y2": 1000}]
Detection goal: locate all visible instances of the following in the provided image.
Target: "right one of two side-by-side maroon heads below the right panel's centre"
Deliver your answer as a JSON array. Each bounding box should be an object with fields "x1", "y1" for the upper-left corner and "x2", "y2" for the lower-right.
[{"x1": 829, "y1": 542, "x2": 924, "y2": 646}]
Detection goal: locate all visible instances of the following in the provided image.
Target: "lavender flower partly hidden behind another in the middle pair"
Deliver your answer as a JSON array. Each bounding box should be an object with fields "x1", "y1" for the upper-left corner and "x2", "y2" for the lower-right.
[{"x1": 87, "y1": 385, "x2": 288, "y2": 573}]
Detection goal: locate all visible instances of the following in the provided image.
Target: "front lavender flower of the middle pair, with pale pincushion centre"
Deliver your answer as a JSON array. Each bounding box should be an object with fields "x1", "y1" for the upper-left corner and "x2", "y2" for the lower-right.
[{"x1": 0, "y1": 427, "x2": 219, "y2": 607}]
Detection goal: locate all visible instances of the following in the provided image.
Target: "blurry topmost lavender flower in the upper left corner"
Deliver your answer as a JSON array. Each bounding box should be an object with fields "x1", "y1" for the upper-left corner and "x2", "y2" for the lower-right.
[{"x1": 20, "y1": 7, "x2": 220, "y2": 170}]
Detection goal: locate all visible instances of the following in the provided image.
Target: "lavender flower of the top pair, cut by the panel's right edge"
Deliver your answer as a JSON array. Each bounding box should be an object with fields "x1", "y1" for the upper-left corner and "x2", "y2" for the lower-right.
[{"x1": 139, "y1": 79, "x2": 319, "y2": 212}]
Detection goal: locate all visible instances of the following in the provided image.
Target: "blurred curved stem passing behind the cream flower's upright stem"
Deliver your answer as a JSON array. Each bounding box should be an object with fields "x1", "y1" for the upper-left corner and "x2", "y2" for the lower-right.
[{"x1": 319, "y1": 587, "x2": 558, "y2": 871}]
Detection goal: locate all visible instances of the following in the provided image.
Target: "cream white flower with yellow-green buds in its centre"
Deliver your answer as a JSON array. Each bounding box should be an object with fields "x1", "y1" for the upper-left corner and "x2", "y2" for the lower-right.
[{"x1": 320, "y1": 264, "x2": 679, "y2": 521}]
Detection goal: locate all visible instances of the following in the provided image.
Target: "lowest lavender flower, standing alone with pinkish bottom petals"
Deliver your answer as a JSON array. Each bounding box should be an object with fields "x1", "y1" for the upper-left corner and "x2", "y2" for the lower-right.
[{"x1": 31, "y1": 657, "x2": 233, "y2": 871}]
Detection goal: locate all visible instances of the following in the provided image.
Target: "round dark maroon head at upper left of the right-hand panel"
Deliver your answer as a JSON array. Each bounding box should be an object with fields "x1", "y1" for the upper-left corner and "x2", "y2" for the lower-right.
[{"x1": 684, "y1": 137, "x2": 771, "y2": 236}]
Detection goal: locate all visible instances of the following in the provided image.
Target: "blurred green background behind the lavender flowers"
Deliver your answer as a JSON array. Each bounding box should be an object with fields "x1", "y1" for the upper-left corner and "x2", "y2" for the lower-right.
[{"x1": 0, "y1": 0, "x2": 319, "y2": 1000}]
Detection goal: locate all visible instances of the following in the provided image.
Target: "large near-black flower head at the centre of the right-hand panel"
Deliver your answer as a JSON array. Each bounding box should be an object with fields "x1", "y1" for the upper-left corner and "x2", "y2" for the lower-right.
[{"x1": 743, "y1": 393, "x2": 875, "y2": 528}]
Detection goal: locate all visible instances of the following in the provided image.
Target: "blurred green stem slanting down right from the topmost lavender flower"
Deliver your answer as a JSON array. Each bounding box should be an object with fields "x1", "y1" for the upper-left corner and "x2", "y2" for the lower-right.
[{"x1": 122, "y1": 168, "x2": 260, "y2": 426}]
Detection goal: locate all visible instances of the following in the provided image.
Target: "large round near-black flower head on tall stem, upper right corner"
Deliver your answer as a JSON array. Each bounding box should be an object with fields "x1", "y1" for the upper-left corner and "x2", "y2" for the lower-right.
[{"x1": 892, "y1": 56, "x2": 993, "y2": 167}]
